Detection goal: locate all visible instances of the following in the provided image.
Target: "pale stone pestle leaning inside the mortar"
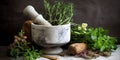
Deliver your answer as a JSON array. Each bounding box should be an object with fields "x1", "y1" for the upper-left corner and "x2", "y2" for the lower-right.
[{"x1": 23, "y1": 5, "x2": 52, "y2": 26}]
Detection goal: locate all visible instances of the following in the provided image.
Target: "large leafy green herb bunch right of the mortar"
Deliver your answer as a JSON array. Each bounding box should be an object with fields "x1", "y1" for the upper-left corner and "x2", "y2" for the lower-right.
[{"x1": 71, "y1": 23, "x2": 117, "y2": 52}]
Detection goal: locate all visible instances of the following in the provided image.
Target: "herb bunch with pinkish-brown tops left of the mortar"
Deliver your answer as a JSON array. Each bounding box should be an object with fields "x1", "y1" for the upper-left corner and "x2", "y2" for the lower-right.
[{"x1": 9, "y1": 30, "x2": 42, "y2": 60}]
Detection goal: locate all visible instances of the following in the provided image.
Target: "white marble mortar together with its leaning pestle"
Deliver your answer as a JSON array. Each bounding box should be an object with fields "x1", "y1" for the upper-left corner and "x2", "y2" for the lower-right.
[{"x1": 23, "y1": 5, "x2": 71, "y2": 54}]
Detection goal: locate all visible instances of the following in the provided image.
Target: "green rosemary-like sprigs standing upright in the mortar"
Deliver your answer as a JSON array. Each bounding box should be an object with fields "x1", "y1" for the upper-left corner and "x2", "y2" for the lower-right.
[{"x1": 43, "y1": 0, "x2": 73, "y2": 25}]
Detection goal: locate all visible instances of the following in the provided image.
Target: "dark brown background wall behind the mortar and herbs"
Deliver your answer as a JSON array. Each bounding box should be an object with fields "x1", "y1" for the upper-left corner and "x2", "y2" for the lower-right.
[{"x1": 0, "y1": 0, "x2": 120, "y2": 45}]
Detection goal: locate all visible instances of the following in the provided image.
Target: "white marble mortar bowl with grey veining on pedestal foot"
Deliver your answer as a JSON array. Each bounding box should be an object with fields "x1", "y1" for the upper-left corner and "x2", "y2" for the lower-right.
[{"x1": 31, "y1": 23, "x2": 71, "y2": 54}]
